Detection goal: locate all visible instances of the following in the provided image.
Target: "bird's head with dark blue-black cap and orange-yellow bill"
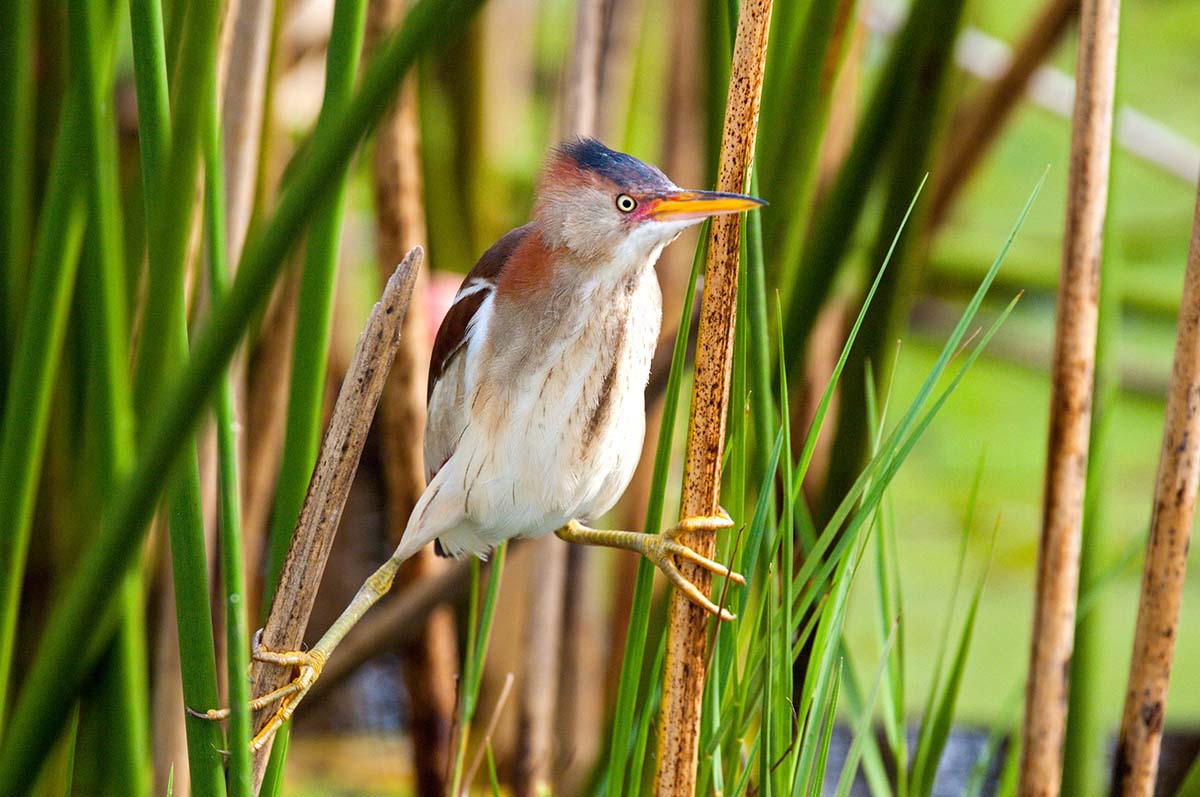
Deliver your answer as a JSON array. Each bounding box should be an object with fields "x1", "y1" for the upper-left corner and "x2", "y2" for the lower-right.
[{"x1": 534, "y1": 138, "x2": 766, "y2": 263}]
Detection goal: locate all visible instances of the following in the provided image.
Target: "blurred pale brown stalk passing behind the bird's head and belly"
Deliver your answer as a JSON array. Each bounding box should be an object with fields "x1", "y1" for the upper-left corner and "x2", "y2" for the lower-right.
[{"x1": 514, "y1": 0, "x2": 607, "y2": 797}]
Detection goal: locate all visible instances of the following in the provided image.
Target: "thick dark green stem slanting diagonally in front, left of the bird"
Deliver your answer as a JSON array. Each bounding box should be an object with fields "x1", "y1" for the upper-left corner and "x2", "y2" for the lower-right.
[{"x1": 0, "y1": 0, "x2": 481, "y2": 793}]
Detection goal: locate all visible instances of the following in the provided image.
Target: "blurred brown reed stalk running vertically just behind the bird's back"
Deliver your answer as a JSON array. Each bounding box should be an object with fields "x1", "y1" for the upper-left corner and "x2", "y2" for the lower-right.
[{"x1": 367, "y1": 0, "x2": 458, "y2": 797}]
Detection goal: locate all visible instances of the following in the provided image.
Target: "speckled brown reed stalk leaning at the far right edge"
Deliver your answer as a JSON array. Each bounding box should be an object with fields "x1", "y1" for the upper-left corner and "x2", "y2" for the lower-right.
[{"x1": 1112, "y1": 184, "x2": 1200, "y2": 797}]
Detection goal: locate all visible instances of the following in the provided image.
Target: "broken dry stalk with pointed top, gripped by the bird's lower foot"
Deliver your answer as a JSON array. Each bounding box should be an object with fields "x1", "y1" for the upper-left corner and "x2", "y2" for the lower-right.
[{"x1": 251, "y1": 248, "x2": 425, "y2": 785}]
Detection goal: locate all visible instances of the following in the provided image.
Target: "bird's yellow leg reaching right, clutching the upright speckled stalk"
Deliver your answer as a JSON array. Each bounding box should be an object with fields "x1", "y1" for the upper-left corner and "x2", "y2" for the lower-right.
[{"x1": 556, "y1": 514, "x2": 746, "y2": 619}]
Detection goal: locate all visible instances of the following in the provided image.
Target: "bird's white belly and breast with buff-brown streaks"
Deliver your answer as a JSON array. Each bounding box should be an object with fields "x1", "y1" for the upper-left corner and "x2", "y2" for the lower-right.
[{"x1": 414, "y1": 268, "x2": 661, "y2": 553}]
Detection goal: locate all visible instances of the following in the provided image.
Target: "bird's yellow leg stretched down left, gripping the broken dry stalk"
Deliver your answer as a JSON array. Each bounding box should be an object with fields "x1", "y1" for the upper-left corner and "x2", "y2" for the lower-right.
[{"x1": 187, "y1": 558, "x2": 400, "y2": 751}]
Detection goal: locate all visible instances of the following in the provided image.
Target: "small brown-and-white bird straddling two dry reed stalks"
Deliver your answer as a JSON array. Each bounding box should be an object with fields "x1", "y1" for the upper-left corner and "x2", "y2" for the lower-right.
[{"x1": 200, "y1": 138, "x2": 766, "y2": 750}]
